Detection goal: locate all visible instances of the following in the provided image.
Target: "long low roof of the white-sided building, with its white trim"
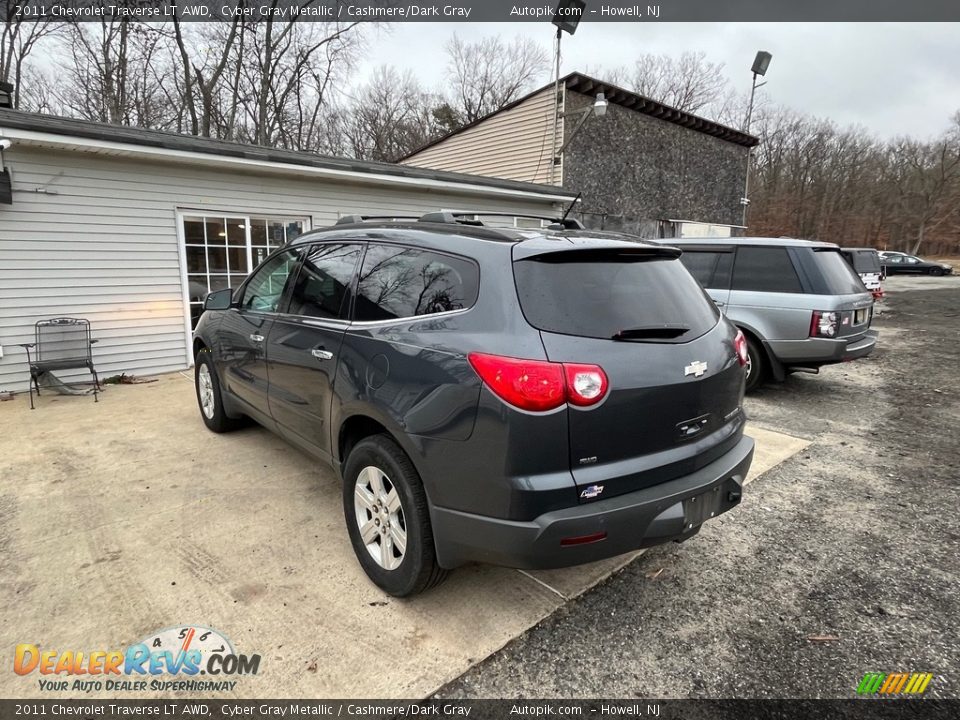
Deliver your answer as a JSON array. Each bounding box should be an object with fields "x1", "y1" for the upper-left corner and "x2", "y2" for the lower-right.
[{"x1": 0, "y1": 109, "x2": 574, "y2": 201}]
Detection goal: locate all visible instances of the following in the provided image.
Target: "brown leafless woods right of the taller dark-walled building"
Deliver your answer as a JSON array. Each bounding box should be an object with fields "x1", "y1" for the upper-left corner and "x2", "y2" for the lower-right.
[{"x1": 750, "y1": 103, "x2": 960, "y2": 254}]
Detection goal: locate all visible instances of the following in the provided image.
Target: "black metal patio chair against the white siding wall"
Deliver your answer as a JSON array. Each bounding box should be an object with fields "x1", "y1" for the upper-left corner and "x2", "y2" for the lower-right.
[{"x1": 21, "y1": 318, "x2": 100, "y2": 410}]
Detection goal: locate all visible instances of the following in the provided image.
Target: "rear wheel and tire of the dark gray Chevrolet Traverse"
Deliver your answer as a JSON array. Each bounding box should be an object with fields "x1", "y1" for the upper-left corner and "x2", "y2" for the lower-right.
[{"x1": 343, "y1": 435, "x2": 448, "y2": 597}]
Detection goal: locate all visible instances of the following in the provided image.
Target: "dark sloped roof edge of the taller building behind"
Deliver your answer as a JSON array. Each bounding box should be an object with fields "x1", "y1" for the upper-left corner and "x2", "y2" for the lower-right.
[{"x1": 398, "y1": 72, "x2": 760, "y2": 162}]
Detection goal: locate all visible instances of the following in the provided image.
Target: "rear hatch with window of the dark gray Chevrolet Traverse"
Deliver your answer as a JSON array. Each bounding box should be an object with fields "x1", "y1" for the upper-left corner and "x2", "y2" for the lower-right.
[{"x1": 514, "y1": 242, "x2": 744, "y2": 500}]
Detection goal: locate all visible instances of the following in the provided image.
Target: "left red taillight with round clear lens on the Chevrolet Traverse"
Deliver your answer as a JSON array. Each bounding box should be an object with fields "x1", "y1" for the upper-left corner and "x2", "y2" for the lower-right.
[{"x1": 468, "y1": 353, "x2": 609, "y2": 412}]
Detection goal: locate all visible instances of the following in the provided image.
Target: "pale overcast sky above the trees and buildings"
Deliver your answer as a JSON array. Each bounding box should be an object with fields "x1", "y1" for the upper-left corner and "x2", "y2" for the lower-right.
[{"x1": 360, "y1": 22, "x2": 960, "y2": 137}]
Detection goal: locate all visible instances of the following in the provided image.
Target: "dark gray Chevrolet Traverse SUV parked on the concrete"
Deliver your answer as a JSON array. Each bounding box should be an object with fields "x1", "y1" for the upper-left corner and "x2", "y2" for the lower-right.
[{"x1": 194, "y1": 213, "x2": 753, "y2": 596}]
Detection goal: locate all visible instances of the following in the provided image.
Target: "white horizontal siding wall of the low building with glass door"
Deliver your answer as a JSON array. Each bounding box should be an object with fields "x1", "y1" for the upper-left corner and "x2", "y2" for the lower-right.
[{"x1": 0, "y1": 145, "x2": 564, "y2": 390}]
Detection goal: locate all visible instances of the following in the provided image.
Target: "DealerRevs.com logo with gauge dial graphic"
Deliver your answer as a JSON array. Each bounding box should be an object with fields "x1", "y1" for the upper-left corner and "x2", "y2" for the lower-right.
[{"x1": 13, "y1": 625, "x2": 260, "y2": 692}]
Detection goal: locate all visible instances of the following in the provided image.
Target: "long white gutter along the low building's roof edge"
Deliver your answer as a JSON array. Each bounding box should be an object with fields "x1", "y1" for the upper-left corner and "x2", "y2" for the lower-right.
[{"x1": 0, "y1": 127, "x2": 574, "y2": 202}]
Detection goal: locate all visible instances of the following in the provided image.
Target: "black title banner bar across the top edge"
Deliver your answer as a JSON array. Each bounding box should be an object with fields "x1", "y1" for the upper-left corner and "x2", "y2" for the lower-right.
[{"x1": 0, "y1": 0, "x2": 960, "y2": 23}]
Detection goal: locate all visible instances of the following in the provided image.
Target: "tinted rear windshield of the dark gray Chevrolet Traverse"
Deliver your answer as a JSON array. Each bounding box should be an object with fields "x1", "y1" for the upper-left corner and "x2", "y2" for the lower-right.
[{"x1": 513, "y1": 251, "x2": 720, "y2": 342}]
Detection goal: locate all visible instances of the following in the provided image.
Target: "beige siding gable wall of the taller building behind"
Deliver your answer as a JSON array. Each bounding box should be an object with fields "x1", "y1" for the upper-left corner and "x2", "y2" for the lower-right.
[{"x1": 402, "y1": 87, "x2": 563, "y2": 185}]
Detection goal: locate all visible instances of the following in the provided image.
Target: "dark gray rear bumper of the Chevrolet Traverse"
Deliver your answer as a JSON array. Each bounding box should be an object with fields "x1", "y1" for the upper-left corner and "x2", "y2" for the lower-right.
[{"x1": 431, "y1": 437, "x2": 754, "y2": 569}]
